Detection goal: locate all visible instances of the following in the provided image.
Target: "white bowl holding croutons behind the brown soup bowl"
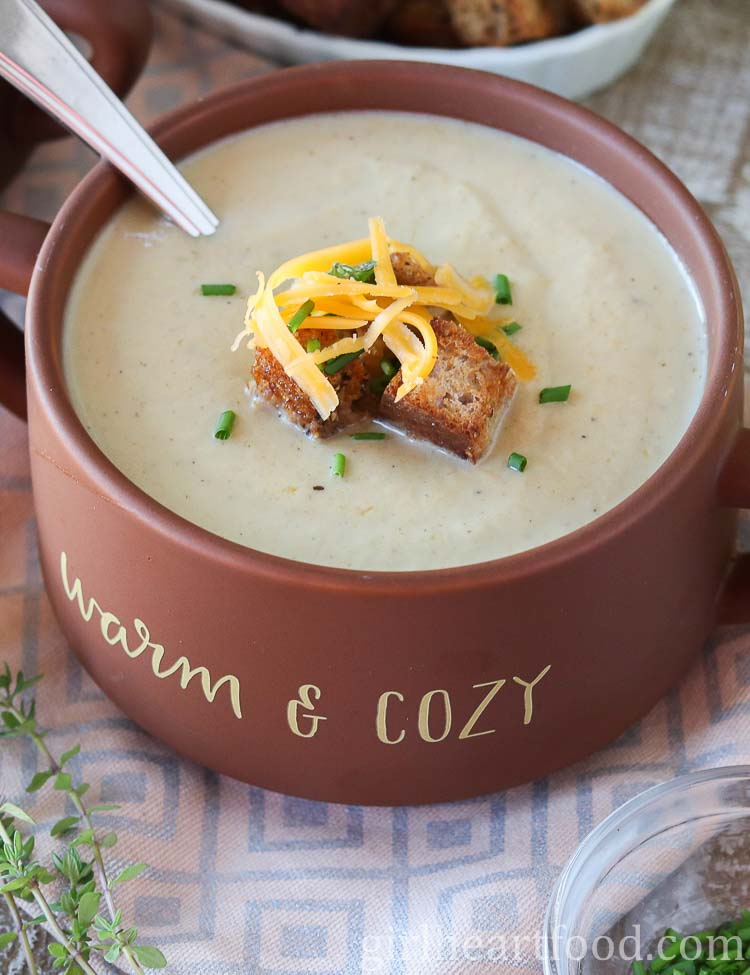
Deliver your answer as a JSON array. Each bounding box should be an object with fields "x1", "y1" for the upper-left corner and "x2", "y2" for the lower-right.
[{"x1": 160, "y1": 0, "x2": 675, "y2": 98}]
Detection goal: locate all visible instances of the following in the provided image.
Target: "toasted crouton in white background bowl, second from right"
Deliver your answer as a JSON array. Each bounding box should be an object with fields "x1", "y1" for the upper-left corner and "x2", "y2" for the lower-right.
[{"x1": 447, "y1": 0, "x2": 570, "y2": 47}]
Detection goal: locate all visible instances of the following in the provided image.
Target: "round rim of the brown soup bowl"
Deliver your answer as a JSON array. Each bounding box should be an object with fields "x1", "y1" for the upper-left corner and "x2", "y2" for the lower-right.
[{"x1": 26, "y1": 60, "x2": 742, "y2": 596}]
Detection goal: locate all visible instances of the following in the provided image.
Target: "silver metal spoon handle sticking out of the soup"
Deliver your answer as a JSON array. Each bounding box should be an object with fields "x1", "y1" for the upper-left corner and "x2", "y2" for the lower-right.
[{"x1": 0, "y1": 0, "x2": 219, "y2": 237}]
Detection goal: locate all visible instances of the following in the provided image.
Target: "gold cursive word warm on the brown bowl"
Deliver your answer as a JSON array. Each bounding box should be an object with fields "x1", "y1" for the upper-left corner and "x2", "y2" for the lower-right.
[{"x1": 60, "y1": 552, "x2": 242, "y2": 718}]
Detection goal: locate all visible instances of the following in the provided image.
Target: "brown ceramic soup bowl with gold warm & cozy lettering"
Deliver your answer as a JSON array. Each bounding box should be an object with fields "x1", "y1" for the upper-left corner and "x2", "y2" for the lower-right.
[{"x1": 0, "y1": 62, "x2": 750, "y2": 804}]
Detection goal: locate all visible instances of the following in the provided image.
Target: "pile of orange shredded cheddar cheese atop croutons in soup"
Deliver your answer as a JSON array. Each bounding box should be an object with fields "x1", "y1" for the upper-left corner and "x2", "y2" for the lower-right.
[{"x1": 232, "y1": 217, "x2": 535, "y2": 420}]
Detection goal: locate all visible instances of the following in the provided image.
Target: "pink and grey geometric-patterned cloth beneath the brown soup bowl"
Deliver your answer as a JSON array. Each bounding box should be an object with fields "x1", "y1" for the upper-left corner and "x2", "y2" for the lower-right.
[{"x1": 0, "y1": 0, "x2": 750, "y2": 975}]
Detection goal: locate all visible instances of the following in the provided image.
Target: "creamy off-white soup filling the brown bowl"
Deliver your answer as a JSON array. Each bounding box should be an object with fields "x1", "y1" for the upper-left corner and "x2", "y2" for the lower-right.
[{"x1": 64, "y1": 113, "x2": 707, "y2": 570}]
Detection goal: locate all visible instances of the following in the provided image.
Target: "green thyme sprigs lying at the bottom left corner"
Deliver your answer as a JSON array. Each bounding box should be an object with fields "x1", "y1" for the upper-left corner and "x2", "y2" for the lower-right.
[{"x1": 0, "y1": 663, "x2": 167, "y2": 975}]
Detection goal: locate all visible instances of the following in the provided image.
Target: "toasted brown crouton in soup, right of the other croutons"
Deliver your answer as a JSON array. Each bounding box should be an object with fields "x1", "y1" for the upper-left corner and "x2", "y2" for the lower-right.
[{"x1": 380, "y1": 318, "x2": 517, "y2": 464}]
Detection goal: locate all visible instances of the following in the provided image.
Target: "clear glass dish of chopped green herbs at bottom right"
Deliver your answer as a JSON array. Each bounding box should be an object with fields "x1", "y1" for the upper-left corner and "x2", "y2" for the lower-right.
[{"x1": 542, "y1": 766, "x2": 750, "y2": 975}]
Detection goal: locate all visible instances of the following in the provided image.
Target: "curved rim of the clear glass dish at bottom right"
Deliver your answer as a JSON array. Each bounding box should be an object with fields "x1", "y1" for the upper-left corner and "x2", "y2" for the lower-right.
[{"x1": 542, "y1": 765, "x2": 750, "y2": 975}]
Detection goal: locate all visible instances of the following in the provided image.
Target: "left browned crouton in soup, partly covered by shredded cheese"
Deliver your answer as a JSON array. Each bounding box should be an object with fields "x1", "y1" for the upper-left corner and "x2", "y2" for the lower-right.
[{"x1": 253, "y1": 328, "x2": 368, "y2": 438}]
